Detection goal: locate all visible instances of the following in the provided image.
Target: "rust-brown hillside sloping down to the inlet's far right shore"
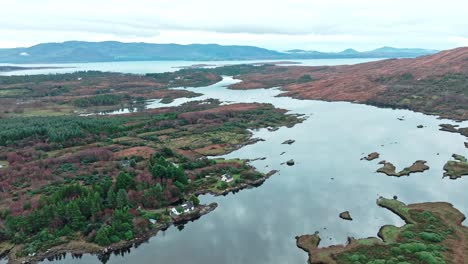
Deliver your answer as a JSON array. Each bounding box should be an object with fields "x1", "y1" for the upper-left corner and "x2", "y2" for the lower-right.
[{"x1": 199, "y1": 48, "x2": 468, "y2": 120}]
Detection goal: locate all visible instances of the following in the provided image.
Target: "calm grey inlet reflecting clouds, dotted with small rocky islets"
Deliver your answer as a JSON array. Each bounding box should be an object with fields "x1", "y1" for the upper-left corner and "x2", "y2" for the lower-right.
[{"x1": 3, "y1": 59, "x2": 468, "y2": 264}]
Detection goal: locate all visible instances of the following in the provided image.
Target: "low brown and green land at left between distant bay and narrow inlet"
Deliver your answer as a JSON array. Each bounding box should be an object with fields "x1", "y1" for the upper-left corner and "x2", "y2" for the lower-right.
[{"x1": 0, "y1": 70, "x2": 222, "y2": 117}]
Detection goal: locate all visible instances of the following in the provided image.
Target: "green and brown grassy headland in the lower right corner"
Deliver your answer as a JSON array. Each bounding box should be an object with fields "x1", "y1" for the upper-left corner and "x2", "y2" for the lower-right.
[{"x1": 296, "y1": 198, "x2": 468, "y2": 264}]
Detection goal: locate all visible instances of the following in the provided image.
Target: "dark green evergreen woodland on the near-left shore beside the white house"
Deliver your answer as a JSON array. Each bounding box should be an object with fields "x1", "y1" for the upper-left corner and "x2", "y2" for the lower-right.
[{"x1": 0, "y1": 153, "x2": 199, "y2": 254}]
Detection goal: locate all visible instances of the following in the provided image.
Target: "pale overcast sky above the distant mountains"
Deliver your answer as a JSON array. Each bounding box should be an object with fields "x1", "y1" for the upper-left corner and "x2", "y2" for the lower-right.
[{"x1": 0, "y1": 0, "x2": 468, "y2": 51}]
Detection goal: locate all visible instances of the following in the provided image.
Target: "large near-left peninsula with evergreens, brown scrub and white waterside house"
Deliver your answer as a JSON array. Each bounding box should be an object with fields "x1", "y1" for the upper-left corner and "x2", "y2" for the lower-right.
[{"x1": 0, "y1": 94, "x2": 301, "y2": 263}]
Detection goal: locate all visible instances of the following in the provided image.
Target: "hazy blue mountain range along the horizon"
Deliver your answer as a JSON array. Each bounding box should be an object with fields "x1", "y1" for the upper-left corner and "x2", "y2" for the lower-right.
[{"x1": 0, "y1": 41, "x2": 437, "y2": 63}]
